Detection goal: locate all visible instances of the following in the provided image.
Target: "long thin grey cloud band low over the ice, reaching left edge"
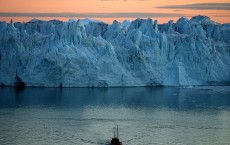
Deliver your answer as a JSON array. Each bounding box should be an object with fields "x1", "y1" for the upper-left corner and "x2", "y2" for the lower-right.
[{"x1": 0, "y1": 12, "x2": 185, "y2": 18}]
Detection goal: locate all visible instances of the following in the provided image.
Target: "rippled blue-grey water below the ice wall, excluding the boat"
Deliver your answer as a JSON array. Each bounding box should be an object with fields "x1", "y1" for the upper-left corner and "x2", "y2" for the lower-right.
[{"x1": 0, "y1": 87, "x2": 230, "y2": 145}]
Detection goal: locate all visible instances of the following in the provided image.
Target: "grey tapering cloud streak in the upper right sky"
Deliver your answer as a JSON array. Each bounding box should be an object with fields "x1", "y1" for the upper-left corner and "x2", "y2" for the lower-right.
[{"x1": 157, "y1": 3, "x2": 230, "y2": 10}]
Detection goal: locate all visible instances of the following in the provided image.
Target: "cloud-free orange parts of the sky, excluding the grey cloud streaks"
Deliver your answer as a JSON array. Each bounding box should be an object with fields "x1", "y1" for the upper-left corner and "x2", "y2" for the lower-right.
[{"x1": 0, "y1": 0, "x2": 230, "y2": 23}]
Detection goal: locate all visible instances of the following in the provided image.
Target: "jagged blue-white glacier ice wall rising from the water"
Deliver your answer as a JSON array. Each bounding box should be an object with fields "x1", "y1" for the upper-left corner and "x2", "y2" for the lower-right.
[{"x1": 0, "y1": 16, "x2": 230, "y2": 87}]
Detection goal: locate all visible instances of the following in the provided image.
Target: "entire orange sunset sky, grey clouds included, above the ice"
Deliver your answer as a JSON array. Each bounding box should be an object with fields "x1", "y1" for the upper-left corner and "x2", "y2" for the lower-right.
[{"x1": 0, "y1": 0, "x2": 230, "y2": 23}]
